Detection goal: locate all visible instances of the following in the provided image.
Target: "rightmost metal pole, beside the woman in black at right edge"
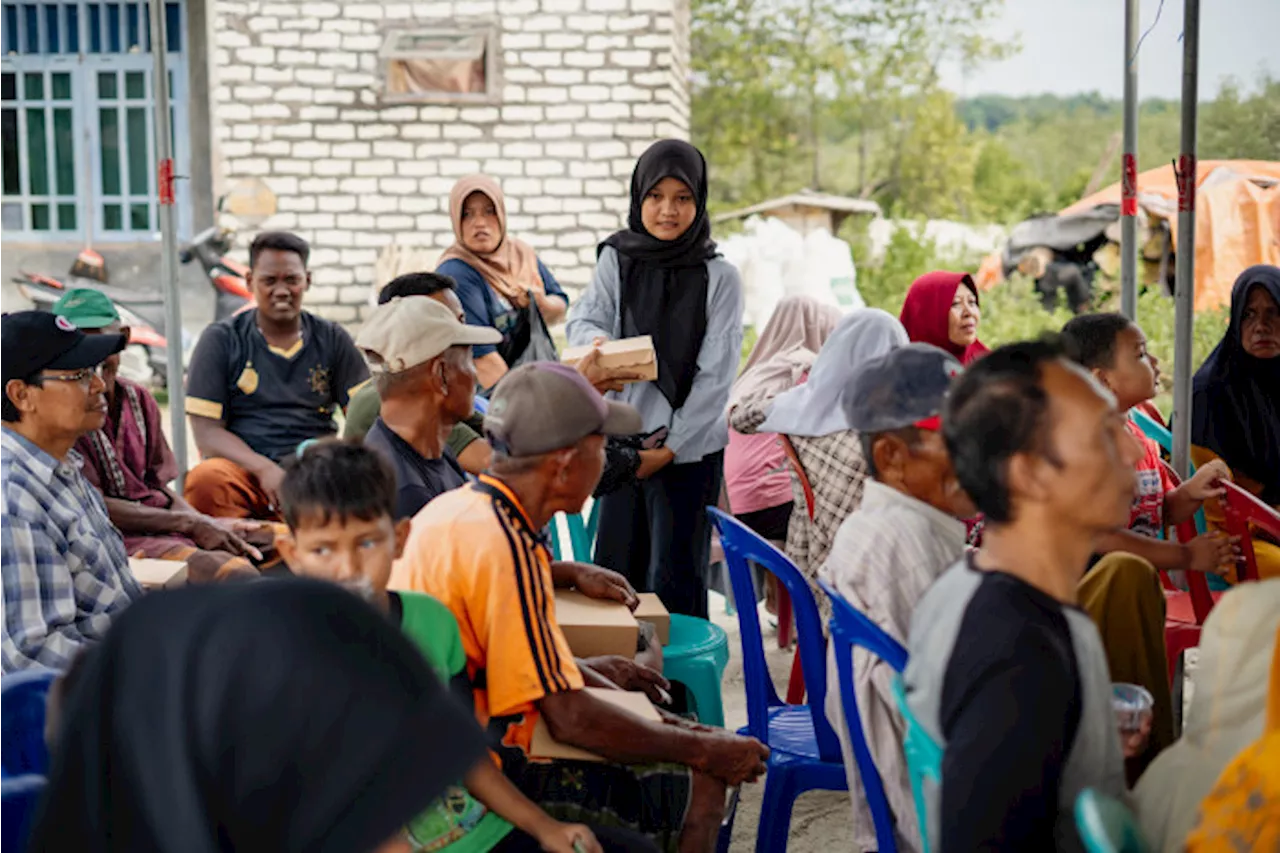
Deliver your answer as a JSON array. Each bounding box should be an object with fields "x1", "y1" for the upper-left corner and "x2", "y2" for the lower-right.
[{"x1": 1172, "y1": 0, "x2": 1199, "y2": 478}]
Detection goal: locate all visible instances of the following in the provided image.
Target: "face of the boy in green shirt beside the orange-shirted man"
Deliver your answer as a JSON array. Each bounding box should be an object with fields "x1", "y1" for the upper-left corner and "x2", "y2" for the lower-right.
[{"x1": 276, "y1": 514, "x2": 410, "y2": 596}]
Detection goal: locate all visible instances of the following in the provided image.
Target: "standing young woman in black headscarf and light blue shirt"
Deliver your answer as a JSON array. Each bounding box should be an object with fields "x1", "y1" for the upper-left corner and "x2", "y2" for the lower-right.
[{"x1": 567, "y1": 140, "x2": 742, "y2": 617}]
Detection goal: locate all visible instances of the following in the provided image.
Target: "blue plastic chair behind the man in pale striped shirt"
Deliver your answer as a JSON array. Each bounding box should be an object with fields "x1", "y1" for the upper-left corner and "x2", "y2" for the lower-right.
[{"x1": 805, "y1": 580, "x2": 906, "y2": 853}]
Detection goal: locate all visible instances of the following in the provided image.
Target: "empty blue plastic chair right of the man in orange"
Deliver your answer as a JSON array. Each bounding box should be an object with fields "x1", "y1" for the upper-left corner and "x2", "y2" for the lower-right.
[{"x1": 707, "y1": 507, "x2": 844, "y2": 853}]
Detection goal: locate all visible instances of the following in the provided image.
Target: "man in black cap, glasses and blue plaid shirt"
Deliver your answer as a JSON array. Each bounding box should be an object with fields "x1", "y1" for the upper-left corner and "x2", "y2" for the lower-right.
[{"x1": 0, "y1": 311, "x2": 142, "y2": 674}]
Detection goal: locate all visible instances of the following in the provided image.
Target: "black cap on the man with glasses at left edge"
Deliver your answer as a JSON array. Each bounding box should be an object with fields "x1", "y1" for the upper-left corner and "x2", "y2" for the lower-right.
[{"x1": 0, "y1": 311, "x2": 128, "y2": 388}]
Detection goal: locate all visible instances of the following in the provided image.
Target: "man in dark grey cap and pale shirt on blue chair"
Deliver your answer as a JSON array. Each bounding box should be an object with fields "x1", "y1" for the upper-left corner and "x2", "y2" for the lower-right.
[{"x1": 818, "y1": 343, "x2": 973, "y2": 850}]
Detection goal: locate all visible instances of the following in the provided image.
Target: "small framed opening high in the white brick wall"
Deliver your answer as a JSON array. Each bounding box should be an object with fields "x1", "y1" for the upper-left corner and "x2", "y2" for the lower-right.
[{"x1": 381, "y1": 24, "x2": 499, "y2": 102}]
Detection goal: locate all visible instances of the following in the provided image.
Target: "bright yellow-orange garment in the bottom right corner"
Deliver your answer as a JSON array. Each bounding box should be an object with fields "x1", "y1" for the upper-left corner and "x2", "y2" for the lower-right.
[{"x1": 1187, "y1": 622, "x2": 1280, "y2": 853}]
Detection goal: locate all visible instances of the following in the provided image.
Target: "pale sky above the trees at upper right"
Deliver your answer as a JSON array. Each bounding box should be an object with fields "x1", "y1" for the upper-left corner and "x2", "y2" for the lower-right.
[{"x1": 943, "y1": 0, "x2": 1280, "y2": 100}]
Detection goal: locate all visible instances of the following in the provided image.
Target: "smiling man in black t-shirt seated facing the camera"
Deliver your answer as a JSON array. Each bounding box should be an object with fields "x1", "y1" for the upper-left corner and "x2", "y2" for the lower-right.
[{"x1": 184, "y1": 232, "x2": 369, "y2": 519}]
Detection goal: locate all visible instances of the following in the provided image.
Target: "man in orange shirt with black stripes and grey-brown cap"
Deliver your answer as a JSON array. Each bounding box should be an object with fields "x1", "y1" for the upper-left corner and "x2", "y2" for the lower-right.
[{"x1": 392, "y1": 362, "x2": 768, "y2": 853}]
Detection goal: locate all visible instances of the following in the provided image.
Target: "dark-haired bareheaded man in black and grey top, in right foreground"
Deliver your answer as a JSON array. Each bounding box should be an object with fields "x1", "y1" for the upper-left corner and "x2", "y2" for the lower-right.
[{"x1": 905, "y1": 341, "x2": 1151, "y2": 853}]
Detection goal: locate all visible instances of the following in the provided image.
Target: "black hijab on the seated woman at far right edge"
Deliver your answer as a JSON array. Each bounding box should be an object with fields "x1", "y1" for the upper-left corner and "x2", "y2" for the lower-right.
[{"x1": 1192, "y1": 265, "x2": 1280, "y2": 505}]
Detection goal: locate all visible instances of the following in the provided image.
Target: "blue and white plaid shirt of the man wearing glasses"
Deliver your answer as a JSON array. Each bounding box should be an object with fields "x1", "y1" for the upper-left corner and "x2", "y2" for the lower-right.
[{"x1": 0, "y1": 428, "x2": 142, "y2": 674}]
